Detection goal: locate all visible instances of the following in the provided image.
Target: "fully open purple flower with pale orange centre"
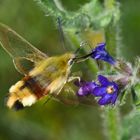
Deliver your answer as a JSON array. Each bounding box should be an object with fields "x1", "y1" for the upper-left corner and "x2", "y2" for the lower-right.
[{"x1": 92, "y1": 75, "x2": 119, "y2": 105}]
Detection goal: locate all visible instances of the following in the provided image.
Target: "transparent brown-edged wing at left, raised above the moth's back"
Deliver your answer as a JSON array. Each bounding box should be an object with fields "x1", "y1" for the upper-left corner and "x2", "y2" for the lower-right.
[{"x1": 0, "y1": 23, "x2": 47, "y2": 74}]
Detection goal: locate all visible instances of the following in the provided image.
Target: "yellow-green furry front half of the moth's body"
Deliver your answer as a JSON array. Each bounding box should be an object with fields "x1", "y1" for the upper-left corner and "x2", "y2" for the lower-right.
[{"x1": 29, "y1": 53, "x2": 75, "y2": 94}]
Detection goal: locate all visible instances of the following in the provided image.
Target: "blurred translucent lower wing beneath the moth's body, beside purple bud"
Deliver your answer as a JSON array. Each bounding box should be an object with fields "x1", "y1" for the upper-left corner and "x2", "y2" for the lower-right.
[{"x1": 55, "y1": 82, "x2": 97, "y2": 106}]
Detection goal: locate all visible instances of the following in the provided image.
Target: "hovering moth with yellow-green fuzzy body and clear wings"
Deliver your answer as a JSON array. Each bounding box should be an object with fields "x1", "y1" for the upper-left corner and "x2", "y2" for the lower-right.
[{"x1": 0, "y1": 23, "x2": 95, "y2": 110}]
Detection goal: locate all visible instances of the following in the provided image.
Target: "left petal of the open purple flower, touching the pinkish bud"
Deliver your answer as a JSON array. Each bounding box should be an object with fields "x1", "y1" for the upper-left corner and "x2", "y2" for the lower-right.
[{"x1": 92, "y1": 87, "x2": 106, "y2": 96}]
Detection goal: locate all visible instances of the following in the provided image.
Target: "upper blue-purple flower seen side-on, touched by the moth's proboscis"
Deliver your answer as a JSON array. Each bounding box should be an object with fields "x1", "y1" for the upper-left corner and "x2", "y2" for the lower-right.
[{"x1": 91, "y1": 43, "x2": 116, "y2": 65}]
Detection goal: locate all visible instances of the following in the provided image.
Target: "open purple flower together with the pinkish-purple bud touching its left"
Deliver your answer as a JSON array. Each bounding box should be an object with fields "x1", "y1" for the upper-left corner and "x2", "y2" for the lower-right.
[{"x1": 75, "y1": 75, "x2": 119, "y2": 105}]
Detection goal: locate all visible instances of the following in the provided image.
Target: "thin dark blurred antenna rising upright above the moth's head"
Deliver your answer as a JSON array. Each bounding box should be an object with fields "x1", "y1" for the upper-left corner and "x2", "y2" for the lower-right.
[{"x1": 57, "y1": 17, "x2": 66, "y2": 50}]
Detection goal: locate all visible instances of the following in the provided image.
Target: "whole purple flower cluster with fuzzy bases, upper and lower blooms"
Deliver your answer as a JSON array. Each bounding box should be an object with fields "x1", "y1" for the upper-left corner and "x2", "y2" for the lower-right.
[{"x1": 76, "y1": 43, "x2": 132, "y2": 105}]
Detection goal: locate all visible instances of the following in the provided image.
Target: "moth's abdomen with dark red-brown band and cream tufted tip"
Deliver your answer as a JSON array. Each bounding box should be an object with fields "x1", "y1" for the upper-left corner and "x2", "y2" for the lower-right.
[{"x1": 6, "y1": 76, "x2": 47, "y2": 110}]
